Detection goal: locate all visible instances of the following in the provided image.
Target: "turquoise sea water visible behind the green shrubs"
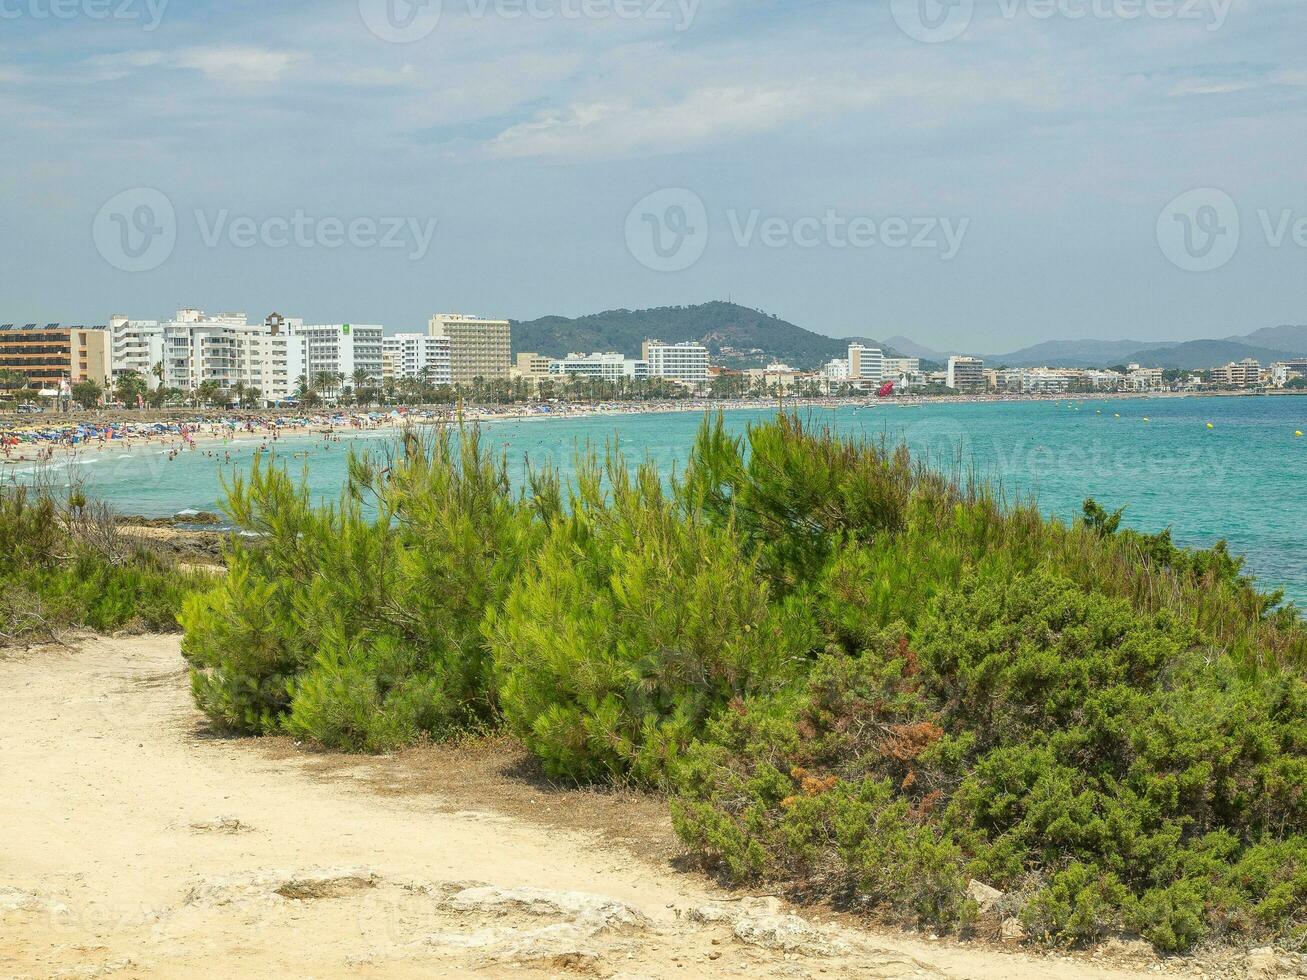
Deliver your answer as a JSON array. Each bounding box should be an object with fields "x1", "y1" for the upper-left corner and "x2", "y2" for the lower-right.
[{"x1": 15, "y1": 397, "x2": 1307, "y2": 605}]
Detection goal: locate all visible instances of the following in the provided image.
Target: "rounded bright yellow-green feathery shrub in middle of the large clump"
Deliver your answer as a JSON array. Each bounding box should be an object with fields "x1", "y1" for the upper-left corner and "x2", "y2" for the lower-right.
[{"x1": 486, "y1": 459, "x2": 816, "y2": 783}]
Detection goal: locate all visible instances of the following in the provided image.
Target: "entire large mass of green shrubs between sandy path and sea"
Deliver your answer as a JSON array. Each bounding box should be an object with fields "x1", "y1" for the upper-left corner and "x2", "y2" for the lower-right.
[{"x1": 183, "y1": 416, "x2": 1307, "y2": 950}]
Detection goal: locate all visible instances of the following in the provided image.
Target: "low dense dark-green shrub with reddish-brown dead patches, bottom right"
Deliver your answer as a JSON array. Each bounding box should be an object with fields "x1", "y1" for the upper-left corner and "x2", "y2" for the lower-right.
[{"x1": 674, "y1": 570, "x2": 1307, "y2": 950}]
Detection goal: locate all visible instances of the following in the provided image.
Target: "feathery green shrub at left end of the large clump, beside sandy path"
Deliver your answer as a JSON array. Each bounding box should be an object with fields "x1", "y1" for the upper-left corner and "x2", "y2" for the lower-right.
[{"x1": 183, "y1": 430, "x2": 548, "y2": 751}]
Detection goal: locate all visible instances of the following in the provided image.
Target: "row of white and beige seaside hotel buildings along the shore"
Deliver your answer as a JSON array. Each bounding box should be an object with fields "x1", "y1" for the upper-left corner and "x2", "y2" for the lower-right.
[{"x1": 0, "y1": 308, "x2": 1307, "y2": 413}]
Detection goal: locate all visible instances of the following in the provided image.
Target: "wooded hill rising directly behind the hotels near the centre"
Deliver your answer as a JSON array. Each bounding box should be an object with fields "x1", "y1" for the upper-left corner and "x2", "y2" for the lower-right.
[{"x1": 512, "y1": 302, "x2": 890, "y2": 370}]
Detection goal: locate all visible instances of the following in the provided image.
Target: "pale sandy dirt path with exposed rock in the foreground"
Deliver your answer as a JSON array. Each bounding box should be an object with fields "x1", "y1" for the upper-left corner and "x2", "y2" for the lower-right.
[{"x1": 0, "y1": 638, "x2": 1197, "y2": 980}]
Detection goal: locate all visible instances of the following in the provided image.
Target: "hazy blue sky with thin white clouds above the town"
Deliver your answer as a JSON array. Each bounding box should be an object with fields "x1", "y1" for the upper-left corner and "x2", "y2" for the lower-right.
[{"x1": 0, "y1": 0, "x2": 1307, "y2": 353}]
